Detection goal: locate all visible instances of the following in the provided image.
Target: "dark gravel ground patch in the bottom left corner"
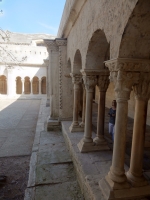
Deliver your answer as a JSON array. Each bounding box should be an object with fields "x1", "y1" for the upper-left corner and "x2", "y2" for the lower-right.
[{"x1": 0, "y1": 156, "x2": 30, "y2": 200}]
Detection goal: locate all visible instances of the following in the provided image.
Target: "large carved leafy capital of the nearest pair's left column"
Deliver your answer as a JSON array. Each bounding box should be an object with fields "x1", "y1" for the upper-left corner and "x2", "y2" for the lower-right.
[{"x1": 110, "y1": 71, "x2": 140, "y2": 102}]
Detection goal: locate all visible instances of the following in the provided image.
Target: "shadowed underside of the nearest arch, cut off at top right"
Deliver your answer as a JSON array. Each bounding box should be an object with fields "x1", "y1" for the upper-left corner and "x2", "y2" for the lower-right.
[{"x1": 119, "y1": 0, "x2": 150, "y2": 59}]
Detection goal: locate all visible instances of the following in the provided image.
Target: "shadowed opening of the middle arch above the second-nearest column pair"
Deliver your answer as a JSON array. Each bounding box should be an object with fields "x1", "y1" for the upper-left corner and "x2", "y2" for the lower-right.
[{"x1": 85, "y1": 29, "x2": 110, "y2": 69}]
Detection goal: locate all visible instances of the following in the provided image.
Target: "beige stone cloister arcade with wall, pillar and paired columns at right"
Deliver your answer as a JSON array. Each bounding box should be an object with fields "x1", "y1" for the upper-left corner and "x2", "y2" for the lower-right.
[{"x1": 44, "y1": 0, "x2": 150, "y2": 199}]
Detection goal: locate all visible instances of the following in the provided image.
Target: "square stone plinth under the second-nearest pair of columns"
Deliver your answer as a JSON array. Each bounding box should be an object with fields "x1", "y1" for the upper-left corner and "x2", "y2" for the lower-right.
[{"x1": 77, "y1": 139, "x2": 108, "y2": 153}]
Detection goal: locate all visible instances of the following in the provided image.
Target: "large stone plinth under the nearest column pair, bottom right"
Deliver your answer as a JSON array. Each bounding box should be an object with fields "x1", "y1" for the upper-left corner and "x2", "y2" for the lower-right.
[{"x1": 99, "y1": 176, "x2": 150, "y2": 200}]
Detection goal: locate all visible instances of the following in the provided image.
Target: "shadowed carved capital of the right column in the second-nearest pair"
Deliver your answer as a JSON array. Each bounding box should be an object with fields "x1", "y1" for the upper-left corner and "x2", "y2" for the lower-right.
[{"x1": 97, "y1": 75, "x2": 110, "y2": 92}]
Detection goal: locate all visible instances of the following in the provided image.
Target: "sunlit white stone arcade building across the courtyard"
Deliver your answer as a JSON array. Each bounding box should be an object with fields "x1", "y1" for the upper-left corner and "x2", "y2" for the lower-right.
[{"x1": 0, "y1": 31, "x2": 54, "y2": 98}]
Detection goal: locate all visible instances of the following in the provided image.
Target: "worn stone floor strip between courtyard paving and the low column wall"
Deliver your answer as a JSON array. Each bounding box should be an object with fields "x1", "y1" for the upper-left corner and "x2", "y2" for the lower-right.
[{"x1": 24, "y1": 99, "x2": 84, "y2": 200}]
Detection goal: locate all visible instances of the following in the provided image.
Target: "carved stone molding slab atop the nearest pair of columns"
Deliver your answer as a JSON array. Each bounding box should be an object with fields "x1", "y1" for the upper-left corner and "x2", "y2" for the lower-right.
[{"x1": 105, "y1": 58, "x2": 150, "y2": 72}]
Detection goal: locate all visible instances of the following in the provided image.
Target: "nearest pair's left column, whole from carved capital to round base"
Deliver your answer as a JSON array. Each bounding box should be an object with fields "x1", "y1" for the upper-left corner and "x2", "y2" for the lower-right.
[{"x1": 99, "y1": 70, "x2": 139, "y2": 192}]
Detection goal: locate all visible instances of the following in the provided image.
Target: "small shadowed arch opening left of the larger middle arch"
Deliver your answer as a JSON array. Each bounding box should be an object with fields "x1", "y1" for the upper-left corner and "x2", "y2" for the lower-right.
[{"x1": 72, "y1": 49, "x2": 82, "y2": 74}]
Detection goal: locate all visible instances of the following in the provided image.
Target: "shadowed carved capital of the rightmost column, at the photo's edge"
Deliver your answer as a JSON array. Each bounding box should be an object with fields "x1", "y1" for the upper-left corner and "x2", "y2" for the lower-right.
[{"x1": 133, "y1": 73, "x2": 150, "y2": 101}]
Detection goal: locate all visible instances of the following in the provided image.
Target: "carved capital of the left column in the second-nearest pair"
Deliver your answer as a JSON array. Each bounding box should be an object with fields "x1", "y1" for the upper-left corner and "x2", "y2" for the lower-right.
[{"x1": 83, "y1": 75, "x2": 97, "y2": 92}]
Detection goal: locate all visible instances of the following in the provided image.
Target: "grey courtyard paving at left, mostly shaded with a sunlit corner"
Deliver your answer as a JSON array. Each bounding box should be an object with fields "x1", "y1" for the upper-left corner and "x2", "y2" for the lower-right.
[{"x1": 0, "y1": 99, "x2": 41, "y2": 157}]
